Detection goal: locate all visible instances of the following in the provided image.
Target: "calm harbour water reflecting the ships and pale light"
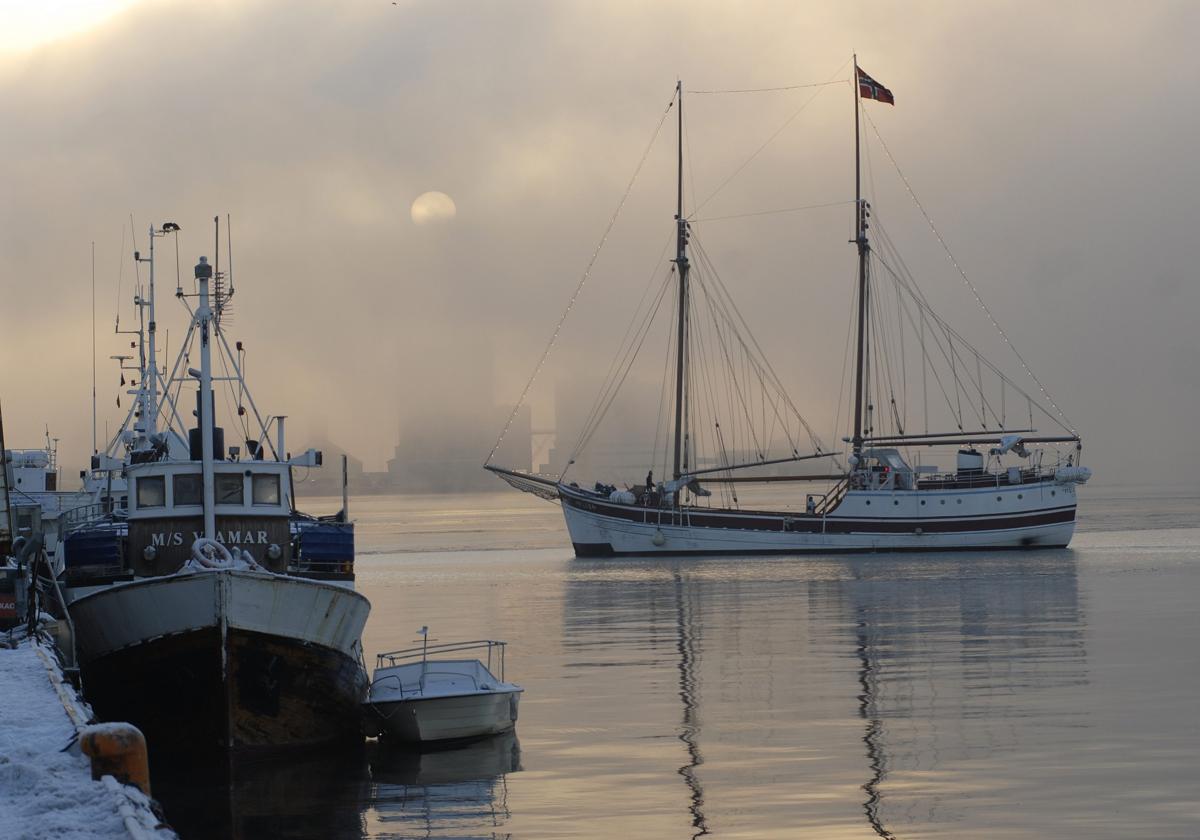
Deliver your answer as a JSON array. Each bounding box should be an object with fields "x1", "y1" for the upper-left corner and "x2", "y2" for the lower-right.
[{"x1": 156, "y1": 488, "x2": 1200, "y2": 840}]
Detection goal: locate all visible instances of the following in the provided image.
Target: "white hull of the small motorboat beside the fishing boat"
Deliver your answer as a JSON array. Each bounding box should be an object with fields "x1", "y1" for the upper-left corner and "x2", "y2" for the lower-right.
[{"x1": 366, "y1": 690, "x2": 521, "y2": 743}]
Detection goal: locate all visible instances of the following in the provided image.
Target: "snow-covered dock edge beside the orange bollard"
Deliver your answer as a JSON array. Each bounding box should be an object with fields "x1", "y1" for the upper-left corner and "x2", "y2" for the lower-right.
[{"x1": 0, "y1": 635, "x2": 176, "y2": 840}]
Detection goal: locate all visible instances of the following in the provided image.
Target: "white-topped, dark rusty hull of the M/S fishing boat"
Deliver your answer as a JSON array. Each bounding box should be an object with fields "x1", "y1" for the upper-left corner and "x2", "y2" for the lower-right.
[{"x1": 71, "y1": 571, "x2": 370, "y2": 756}]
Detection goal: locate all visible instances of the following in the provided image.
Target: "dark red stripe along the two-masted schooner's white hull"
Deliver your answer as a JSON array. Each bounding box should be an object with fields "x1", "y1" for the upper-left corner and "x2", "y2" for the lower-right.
[{"x1": 560, "y1": 492, "x2": 1075, "y2": 534}]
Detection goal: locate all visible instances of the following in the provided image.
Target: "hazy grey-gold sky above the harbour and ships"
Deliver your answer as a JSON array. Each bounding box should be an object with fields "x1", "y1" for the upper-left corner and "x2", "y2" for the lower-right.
[{"x1": 0, "y1": 0, "x2": 1200, "y2": 486}]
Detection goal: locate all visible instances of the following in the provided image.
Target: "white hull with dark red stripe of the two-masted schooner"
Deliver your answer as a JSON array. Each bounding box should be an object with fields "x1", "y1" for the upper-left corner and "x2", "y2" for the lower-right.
[{"x1": 558, "y1": 481, "x2": 1075, "y2": 557}]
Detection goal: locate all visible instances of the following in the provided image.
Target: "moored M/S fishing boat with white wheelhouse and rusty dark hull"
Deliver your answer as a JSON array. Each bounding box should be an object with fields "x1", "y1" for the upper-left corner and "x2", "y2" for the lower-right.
[{"x1": 55, "y1": 224, "x2": 370, "y2": 756}]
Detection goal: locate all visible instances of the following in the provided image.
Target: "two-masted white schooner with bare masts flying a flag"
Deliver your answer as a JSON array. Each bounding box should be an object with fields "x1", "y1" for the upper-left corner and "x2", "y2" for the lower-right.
[{"x1": 485, "y1": 59, "x2": 1091, "y2": 557}]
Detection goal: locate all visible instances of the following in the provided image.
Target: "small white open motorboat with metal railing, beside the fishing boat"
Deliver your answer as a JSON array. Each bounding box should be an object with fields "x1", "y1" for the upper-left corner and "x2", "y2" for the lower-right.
[{"x1": 364, "y1": 628, "x2": 524, "y2": 743}]
